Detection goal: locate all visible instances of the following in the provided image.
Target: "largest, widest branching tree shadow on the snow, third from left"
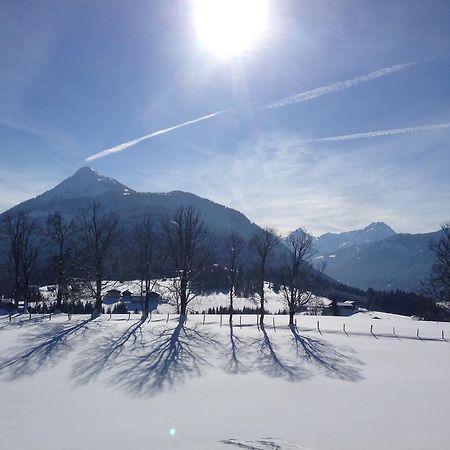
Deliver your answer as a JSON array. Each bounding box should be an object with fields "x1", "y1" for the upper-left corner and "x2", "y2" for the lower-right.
[{"x1": 112, "y1": 321, "x2": 219, "y2": 395}]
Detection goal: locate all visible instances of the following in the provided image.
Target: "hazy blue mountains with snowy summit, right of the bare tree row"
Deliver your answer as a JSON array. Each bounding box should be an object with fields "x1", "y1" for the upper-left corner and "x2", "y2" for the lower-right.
[{"x1": 296, "y1": 222, "x2": 441, "y2": 292}]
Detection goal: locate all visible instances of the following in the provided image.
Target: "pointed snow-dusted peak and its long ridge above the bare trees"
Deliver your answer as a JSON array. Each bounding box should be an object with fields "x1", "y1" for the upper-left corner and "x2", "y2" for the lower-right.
[{"x1": 0, "y1": 167, "x2": 264, "y2": 238}]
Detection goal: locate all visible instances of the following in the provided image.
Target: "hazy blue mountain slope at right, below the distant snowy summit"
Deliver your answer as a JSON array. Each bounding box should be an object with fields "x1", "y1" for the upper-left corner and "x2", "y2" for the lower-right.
[{"x1": 314, "y1": 231, "x2": 441, "y2": 292}]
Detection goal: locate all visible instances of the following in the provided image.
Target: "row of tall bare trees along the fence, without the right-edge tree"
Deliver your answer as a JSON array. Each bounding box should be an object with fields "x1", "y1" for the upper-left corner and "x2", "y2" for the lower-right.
[{"x1": 2, "y1": 202, "x2": 320, "y2": 324}]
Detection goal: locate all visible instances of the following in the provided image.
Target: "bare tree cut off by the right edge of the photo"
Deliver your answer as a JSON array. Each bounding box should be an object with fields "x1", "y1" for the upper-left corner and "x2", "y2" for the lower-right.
[{"x1": 427, "y1": 221, "x2": 450, "y2": 302}]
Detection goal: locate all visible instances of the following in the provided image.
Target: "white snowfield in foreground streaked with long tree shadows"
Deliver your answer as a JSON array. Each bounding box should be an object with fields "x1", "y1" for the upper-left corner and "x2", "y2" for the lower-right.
[{"x1": 0, "y1": 313, "x2": 450, "y2": 450}]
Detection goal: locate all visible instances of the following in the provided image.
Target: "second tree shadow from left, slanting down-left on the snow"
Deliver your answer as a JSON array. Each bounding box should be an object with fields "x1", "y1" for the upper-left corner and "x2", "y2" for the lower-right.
[{"x1": 72, "y1": 319, "x2": 146, "y2": 384}]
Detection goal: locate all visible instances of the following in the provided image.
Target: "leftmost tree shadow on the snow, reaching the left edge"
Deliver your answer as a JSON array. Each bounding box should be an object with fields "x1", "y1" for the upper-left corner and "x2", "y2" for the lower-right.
[{"x1": 0, "y1": 319, "x2": 96, "y2": 381}]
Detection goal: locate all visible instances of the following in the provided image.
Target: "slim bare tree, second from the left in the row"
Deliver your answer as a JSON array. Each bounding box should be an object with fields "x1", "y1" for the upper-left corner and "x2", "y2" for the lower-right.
[{"x1": 47, "y1": 212, "x2": 75, "y2": 310}]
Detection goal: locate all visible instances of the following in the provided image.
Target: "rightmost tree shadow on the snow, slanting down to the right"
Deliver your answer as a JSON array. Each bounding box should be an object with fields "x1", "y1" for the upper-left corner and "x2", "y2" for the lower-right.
[{"x1": 289, "y1": 325, "x2": 362, "y2": 381}]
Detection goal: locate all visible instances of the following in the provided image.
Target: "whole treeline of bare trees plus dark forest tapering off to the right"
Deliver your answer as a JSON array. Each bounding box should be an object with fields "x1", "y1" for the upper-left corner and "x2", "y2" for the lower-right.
[{"x1": 0, "y1": 201, "x2": 441, "y2": 323}]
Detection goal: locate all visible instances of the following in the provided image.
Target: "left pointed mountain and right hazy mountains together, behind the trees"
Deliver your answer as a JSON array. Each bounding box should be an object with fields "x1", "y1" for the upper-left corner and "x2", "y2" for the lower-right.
[{"x1": 0, "y1": 167, "x2": 440, "y2": 291}]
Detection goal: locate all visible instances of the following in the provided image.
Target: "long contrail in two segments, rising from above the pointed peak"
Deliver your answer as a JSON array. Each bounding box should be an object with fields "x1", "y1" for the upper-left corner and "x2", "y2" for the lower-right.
[{"x1": 86, "y1": 62, "x2": 416, "y2": 161}]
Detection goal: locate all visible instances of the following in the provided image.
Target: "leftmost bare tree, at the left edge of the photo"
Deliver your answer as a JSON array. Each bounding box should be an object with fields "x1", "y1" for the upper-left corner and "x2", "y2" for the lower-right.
[{"x1": 2, "y1": 211, "x2": 38, "y2": 310}]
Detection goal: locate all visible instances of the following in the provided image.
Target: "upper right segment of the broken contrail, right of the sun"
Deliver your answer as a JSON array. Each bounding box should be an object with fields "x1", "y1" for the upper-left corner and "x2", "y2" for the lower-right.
[{"x1": 261, "y1": 62, "x2": 416, "y2": 110}]
